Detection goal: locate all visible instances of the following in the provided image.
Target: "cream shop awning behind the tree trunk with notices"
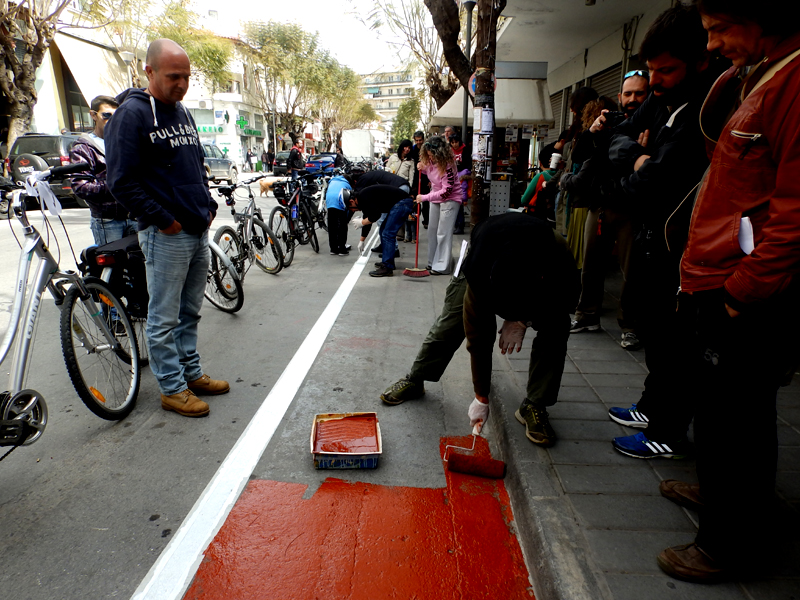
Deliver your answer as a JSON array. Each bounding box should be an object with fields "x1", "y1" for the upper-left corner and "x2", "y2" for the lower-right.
[{"x1": 431, "y1": 79, "x2": 554, "y2": 127}]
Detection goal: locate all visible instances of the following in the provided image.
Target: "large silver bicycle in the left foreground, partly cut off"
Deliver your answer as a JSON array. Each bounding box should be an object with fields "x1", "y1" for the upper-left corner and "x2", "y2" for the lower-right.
[{"x1": 0, "y1": 163, "x2": 141, "y2": 458}]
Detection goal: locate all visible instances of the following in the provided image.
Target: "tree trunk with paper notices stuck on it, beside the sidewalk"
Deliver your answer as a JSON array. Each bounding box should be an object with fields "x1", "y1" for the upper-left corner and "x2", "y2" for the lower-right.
[{"x1": 470, "y1": 0, "x2": 506, "y2": 225}]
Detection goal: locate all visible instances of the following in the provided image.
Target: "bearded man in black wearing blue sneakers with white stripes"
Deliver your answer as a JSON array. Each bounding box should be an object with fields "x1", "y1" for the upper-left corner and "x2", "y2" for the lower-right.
[{"x1": 592, "y1": 6, "x2": 716, "y2": 458}]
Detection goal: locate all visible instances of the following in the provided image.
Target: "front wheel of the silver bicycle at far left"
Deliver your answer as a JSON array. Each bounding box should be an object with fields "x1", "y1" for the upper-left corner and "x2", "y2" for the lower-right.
[{"x1": 61, "y1": 280, "x2": 142, "y2": 421}]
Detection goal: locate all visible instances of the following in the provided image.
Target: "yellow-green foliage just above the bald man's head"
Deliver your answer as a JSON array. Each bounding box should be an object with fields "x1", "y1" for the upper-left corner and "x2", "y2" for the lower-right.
[{"x1": 148, "y1": 2, "x2": 233, "y2": 91}]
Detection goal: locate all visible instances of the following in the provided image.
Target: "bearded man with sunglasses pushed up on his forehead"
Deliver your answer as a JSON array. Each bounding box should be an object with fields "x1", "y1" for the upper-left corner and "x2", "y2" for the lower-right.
[{"x1": 570, "y1": 70, "x2": 649, "y2": 350}]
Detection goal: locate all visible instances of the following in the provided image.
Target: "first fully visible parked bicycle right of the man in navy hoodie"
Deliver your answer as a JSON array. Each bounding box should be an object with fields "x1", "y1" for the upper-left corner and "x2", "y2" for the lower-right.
[{"x1": 214, "y1": 175, "x2": 283, "y2": 283}]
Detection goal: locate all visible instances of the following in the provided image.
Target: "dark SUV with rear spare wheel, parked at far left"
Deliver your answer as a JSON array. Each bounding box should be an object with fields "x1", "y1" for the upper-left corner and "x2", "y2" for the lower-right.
[{"x1": 6, "y1": 132, "x2": 87, "y2": 208}]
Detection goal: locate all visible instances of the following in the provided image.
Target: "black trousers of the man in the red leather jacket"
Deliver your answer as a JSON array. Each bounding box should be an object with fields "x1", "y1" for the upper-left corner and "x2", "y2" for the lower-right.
[{"x1": 679, "y1": 289, "x2": 800, "y2": 569}]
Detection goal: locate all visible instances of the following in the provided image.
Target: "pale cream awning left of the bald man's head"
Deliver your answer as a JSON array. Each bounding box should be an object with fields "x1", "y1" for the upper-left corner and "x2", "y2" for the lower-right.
[{"x1": 54, "y1": 33, "x2": 130, "y2": 106}]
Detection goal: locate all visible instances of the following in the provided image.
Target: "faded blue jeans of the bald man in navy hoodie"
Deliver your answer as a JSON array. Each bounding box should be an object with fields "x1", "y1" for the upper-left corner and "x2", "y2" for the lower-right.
[{"x1": 139, "y1": 225, "x2": 210, "y2": 396}]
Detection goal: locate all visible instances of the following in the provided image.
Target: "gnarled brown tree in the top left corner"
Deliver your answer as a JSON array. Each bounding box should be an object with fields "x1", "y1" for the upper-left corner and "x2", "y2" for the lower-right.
[{"x1": 0, "y1": 0, "x2": 69, "y2": 149}]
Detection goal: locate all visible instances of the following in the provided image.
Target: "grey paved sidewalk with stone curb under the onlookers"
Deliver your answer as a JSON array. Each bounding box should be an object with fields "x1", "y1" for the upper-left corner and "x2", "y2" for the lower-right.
[{"x1": 490, "y1": 279, "x2": 800, "y2": 600}]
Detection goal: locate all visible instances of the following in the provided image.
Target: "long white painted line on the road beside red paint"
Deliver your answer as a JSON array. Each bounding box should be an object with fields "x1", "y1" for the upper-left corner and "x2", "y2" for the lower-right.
[{"x1": 132, "y1": 227, "x2": 378, "y2": 600}]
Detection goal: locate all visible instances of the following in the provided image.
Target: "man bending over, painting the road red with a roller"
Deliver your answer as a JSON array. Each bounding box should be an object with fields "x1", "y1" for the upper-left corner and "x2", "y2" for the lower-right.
[{"x1": 381, "y1": 213, "x2": 580, "y2": 446}]
